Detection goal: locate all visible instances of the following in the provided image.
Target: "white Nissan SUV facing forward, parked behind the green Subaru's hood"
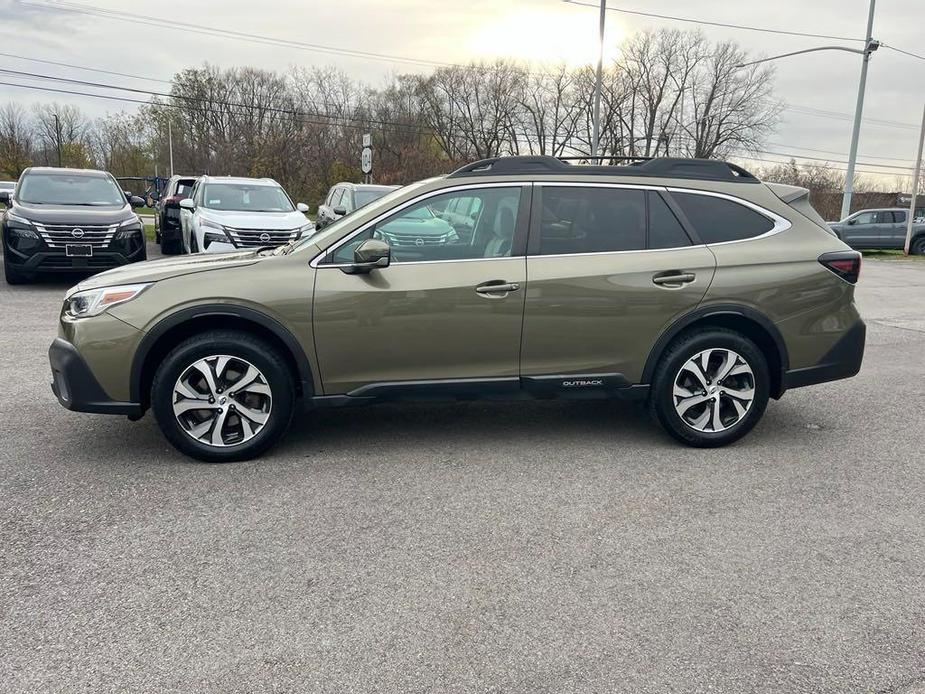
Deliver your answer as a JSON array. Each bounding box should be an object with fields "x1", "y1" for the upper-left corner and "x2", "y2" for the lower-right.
[{"x1": 180, "y1": 176, "x2": 315, "y2": 253}]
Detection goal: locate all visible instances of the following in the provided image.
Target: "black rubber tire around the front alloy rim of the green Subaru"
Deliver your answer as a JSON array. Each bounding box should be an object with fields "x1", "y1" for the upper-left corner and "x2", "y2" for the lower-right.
[{"x1": 151, "y1": 330, "x2": 295, "y2": 463}]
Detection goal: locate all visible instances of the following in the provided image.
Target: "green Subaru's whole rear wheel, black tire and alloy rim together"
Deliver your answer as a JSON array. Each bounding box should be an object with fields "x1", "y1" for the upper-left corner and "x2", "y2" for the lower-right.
[{"x1": 650, "y1": 328, "x2": 770, "y2": 448}]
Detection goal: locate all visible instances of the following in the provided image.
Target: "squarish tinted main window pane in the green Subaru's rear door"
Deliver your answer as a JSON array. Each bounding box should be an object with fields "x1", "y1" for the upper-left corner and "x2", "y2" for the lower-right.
[{"x1": 539, "y1": 186, "x2": 646, "y2": 255}]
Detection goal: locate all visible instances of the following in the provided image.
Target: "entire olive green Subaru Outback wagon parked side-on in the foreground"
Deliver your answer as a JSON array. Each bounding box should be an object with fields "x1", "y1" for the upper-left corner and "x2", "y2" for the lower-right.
[{"x1": 49, "y1": 157, "x2": 865, "y2": 461}]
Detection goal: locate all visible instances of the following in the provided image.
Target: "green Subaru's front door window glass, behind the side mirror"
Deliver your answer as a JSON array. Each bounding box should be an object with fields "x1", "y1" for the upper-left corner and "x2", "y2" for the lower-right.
[{"x1": 327, "y1": 186, "x2": 521, "y2": 265}]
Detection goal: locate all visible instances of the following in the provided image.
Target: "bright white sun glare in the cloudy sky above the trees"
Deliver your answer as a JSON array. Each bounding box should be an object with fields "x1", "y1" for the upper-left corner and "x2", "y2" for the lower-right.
[{"x1": 470, "y1": 8, "x2": 625, "y2": 67}]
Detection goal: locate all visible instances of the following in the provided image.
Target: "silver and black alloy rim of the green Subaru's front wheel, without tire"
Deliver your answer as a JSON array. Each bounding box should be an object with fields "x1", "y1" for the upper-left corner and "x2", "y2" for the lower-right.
[{"x1": 173, "y1": 354, "x2": 273, "y2": 447}]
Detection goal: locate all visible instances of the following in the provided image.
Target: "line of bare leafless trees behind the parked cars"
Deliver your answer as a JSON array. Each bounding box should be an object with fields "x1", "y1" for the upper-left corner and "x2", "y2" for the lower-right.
[{"x1": 0, "y1": 30, "x2": 781, "y2": 203}]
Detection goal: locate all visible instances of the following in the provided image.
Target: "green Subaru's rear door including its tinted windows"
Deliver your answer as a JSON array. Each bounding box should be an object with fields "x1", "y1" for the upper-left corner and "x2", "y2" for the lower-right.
[{"x1": 521, "y1": 183, "x2": 716, "y2": 390}]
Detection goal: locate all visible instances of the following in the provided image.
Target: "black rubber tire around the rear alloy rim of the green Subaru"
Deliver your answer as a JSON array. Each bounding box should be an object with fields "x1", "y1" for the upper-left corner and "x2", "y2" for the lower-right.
[{"x1": 649, "y1": 328, "x2": 770, "y2": 448}]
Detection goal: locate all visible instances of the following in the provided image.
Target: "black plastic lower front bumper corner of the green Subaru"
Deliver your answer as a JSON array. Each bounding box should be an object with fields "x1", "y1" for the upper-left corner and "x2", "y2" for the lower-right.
[{"x1": 48, "y1": 337, "x2": 144, "y2": 417}]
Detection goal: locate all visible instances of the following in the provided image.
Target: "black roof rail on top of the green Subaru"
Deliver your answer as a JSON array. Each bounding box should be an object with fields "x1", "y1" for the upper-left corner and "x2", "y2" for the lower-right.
[{"x1": 447, "y1": 156, "x2": 760, "y2": 183}]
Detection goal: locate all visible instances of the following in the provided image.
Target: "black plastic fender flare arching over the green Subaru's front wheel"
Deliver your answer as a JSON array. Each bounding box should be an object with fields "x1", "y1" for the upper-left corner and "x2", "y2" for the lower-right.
[{"x1": 130, "y1": 304, "x2": 315, "y2": 402}]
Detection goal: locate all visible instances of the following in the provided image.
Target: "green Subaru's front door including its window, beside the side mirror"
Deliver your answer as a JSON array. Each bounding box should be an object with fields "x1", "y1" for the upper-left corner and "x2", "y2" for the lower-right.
[{"x1": 313, "y1": 184, "x2": 530, "y2": 395}]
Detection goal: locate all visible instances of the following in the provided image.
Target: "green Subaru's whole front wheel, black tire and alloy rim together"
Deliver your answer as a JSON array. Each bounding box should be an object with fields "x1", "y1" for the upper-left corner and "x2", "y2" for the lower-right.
[{"x1": 151, "y1": 330, "x2": 295, "y2": 463}]
